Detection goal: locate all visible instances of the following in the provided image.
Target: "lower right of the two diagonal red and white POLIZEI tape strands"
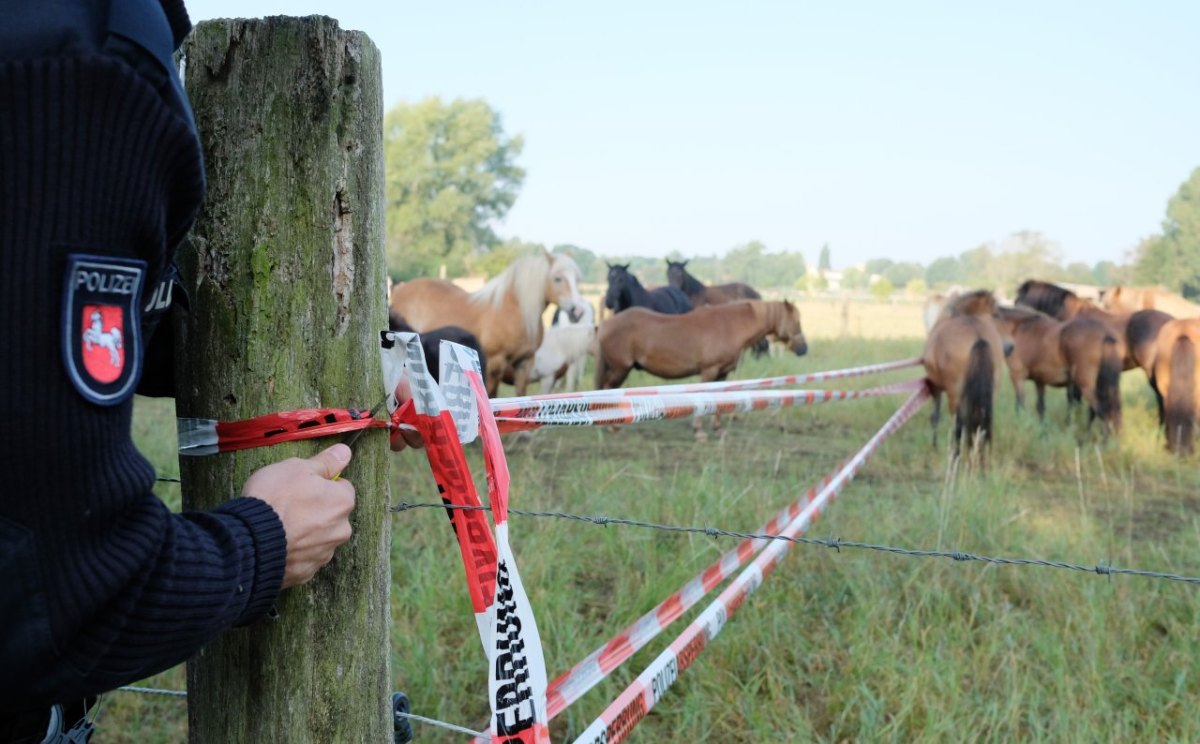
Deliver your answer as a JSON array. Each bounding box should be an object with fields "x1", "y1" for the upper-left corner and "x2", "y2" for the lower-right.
[{"x1": 576, "y1": 388, "x2": 929, "y2": 744}]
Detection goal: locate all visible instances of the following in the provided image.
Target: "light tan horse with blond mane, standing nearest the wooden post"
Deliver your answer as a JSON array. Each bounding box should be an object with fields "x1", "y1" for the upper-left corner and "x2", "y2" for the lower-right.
[{"x1": 391, "y1": 252, "x2": 587, "y2": 396}]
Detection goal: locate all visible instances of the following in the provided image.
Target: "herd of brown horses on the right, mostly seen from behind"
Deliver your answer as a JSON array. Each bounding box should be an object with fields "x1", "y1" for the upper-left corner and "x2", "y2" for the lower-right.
[{"x1": 922, "y1": 280, "x2": 1200, "y2": 456}]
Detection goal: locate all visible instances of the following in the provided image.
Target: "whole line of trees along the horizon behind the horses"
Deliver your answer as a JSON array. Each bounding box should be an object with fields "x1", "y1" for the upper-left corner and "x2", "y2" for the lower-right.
[{"x1": 384, "y1": 97, "x2": 1200, "y2": 296}]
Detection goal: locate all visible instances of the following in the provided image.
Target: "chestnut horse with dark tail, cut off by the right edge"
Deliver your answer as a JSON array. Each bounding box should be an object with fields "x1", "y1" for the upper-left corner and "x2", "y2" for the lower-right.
[{"x1": 1154, "y1": 318, "x2": 1200, "y2": 455}]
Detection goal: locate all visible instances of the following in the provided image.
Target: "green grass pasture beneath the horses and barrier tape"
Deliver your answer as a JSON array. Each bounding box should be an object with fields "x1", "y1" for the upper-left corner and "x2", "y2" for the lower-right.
[{"x1": 94, "y1": 314, "x2": 1200, "y2": 744}]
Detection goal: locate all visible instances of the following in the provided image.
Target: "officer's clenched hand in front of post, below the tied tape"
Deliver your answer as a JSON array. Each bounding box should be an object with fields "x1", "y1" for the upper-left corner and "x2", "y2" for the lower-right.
[{"x1": 242, "y1": 444, "x2": 354, "y2": 589}]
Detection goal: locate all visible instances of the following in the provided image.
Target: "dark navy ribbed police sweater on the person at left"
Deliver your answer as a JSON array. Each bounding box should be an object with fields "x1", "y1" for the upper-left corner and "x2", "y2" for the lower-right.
[{"x1": 0, "y1": 0, "x2": 287, "y2": 712}]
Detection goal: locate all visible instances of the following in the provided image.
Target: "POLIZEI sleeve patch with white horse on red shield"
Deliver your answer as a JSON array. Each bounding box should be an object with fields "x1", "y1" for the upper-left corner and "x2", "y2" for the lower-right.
[{"x1": 62, "y1": 253, "x2": 146, "y2": 406}]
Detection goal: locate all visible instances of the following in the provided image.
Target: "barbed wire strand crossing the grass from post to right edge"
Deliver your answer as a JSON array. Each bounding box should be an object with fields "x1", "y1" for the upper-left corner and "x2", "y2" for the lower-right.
[{"x1": 390, "y1": 502, "x2": 1200, "y2": 584}]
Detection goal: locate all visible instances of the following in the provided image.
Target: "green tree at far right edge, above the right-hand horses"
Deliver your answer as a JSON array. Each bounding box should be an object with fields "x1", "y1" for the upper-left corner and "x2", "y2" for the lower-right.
[{"x1": 1134, "y1": 168, "x2": 1200, "y2": 292}]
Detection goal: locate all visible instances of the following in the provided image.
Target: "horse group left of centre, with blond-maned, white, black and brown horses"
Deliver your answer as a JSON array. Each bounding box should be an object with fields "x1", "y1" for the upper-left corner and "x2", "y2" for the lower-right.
[{"x1": 388, "y1": 252, "x2": 808, "y2": 432}]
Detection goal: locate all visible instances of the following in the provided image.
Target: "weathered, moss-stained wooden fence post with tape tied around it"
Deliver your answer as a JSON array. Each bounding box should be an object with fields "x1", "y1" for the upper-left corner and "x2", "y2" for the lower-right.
[{"x1": 176, "y1": 17, "x2": 391, "y2": 743}]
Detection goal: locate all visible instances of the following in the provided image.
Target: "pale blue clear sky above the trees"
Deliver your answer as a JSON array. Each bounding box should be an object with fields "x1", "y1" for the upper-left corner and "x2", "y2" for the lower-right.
[{"x1": 188, "y1": 0, "x2": 1200, "y2": 268}]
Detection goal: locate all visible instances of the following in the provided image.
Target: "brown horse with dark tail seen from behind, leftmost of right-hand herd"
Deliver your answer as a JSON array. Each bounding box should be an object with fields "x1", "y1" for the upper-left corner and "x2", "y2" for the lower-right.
[{"x1": 922, "y1": 290, "x2": 1004, "y2": 458}]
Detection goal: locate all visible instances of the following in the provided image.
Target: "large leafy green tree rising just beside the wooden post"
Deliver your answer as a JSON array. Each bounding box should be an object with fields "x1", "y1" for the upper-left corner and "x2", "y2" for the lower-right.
[{"x1": 384, "y1": 97, "x2": 524, "y2": 278}]
